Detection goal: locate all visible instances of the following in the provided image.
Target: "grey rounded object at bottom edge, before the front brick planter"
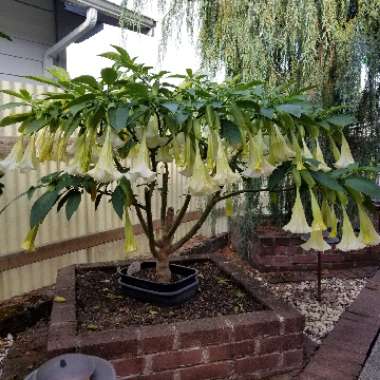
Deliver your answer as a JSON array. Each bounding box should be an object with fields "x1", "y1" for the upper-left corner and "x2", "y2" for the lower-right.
[{"x1": 24, "y1": 354, "x2": 116, "y2": 380}]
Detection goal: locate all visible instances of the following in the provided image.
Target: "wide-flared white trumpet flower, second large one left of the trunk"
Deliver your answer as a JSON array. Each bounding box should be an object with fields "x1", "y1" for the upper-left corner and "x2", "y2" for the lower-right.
[{"x1": 87, "y1": 128, "x2": 121, "y2": 183}]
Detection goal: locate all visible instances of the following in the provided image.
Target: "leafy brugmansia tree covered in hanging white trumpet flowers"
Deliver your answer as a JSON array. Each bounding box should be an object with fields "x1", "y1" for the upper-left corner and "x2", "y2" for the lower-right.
[{"x1": 0, "y1": 46, "x2": 380, "y2": 281}]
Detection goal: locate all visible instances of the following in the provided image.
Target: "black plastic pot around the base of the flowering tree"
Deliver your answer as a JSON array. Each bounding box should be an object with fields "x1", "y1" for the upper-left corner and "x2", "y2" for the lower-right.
[{"x1": 118, "y1": 261, "x2": 199, "y2": 306}]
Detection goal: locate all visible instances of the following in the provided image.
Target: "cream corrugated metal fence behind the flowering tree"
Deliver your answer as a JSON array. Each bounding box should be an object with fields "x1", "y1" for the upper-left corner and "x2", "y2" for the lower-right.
[{"x1": 0, "y1": 82, "x2": 227, "y2": 300}]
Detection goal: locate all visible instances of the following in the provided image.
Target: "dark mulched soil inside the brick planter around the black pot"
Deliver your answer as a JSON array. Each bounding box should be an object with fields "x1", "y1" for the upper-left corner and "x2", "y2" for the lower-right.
[{"x1": 77, "y1": 261, "x2": 264, "y2": 332}]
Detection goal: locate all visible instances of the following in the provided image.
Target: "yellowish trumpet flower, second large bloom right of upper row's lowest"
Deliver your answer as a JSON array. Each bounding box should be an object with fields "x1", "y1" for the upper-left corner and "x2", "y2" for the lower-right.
[{"x1": 242, "y1": 129, "x2": 276, "y2": 178}]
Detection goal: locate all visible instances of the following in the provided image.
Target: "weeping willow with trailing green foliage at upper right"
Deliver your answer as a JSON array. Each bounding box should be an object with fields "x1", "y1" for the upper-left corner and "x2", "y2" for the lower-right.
[{"x1": 123, "y1": 0, "x2": 380, "y2": 235}]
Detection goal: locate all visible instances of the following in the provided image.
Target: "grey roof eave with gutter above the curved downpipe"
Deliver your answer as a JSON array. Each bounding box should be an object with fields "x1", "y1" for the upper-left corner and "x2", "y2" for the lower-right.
[{"x1": 61, "y1": 0, "x2": 156, "y2": 34}]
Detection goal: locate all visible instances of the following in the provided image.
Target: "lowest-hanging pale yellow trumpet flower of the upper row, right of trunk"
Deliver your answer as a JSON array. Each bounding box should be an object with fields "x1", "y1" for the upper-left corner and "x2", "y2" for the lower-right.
[{"x1": 189, "y1": 145, "x2": 219, "y2": 196}]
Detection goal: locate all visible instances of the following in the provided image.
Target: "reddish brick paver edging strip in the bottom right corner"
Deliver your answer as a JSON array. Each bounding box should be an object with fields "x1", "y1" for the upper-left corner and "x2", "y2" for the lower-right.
[{"x1": 300, "y1": 271, "x2": 380, "y2": 380}]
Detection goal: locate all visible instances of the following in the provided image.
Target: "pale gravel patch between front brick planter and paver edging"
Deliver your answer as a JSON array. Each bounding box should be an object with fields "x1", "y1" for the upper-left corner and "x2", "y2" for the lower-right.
[{"x1": 264, "y1": 277, "x2": 367, "y2": 344}]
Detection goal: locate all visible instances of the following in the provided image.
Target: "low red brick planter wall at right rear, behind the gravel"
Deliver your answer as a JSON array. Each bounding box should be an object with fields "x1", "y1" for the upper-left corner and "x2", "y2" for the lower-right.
[{"x1": 231, "y1": 227, "x2": 380, "y2": 271}]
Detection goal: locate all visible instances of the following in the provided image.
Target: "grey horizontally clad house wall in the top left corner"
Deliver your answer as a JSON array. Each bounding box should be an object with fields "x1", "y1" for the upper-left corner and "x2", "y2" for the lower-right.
[{"x1": 0, "y1": 0, "x2": 56, "y2": 80}]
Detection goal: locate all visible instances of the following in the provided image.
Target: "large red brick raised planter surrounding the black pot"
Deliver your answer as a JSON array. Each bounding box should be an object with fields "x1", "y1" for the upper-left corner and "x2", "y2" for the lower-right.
[{"x1": 48, "y1": 246, "x2": 304, "y2": 380}]
